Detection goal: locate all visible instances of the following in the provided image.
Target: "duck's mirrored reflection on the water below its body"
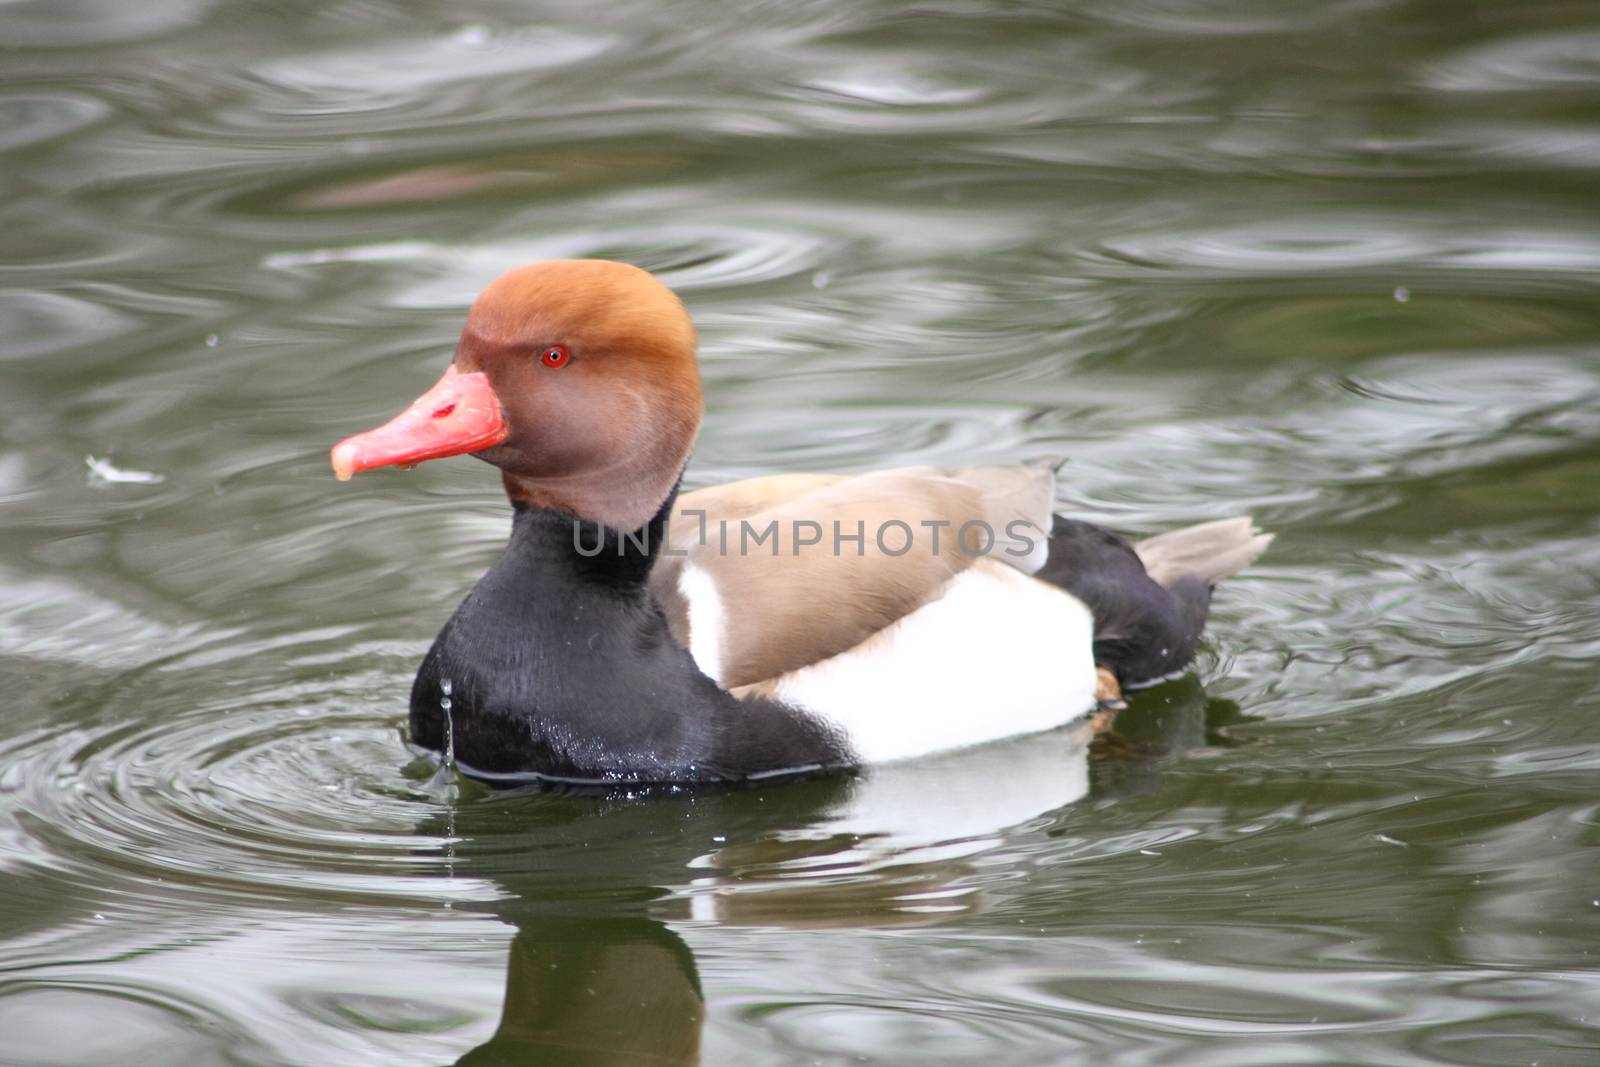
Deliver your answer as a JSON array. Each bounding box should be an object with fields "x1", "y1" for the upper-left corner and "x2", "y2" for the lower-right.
[{"x1": 426, "y1": 678, "x2": 1238, "y2": 1067}]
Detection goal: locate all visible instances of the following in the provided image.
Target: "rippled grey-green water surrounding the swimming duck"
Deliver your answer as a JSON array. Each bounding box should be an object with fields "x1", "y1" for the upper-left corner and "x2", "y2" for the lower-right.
[{"x1": 0, "y1": 0, "x2": 1600, "y2": 1067}]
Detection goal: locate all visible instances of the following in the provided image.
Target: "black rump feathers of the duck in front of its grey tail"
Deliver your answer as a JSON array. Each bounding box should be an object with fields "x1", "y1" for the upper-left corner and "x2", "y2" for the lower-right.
[{"x1": 1037, "y1": 515, "x2": 1211, "y2": 686}]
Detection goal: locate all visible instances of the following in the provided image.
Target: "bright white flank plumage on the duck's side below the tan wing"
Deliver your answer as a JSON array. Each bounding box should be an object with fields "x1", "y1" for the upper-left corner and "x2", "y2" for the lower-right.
[{"x1": 771, "y1": 560, "x2": 1096, "y2": 763}]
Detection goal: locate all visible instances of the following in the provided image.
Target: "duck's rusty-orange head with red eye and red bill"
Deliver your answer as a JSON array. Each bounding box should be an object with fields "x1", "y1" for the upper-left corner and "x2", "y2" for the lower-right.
[{"x1": 331, "y1": 259, "x2": 701, "y2": 531}]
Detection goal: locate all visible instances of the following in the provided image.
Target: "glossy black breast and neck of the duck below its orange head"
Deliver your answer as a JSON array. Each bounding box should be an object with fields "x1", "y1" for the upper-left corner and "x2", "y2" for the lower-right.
[{"x1": 411, "y1": 494, "x2": 854, "y2": 784}]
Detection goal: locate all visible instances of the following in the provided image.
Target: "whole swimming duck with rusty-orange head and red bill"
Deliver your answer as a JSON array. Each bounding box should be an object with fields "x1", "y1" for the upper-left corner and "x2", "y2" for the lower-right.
[{"x1": 330, "y1": 259, "x2": 1272, "y2": 787}]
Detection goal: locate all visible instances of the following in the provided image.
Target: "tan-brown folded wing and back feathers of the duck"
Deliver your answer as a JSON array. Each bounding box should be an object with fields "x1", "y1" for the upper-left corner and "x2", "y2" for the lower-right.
[{"x1": 651, "y1": 464, "x2": 1054, "y2": 686}]
